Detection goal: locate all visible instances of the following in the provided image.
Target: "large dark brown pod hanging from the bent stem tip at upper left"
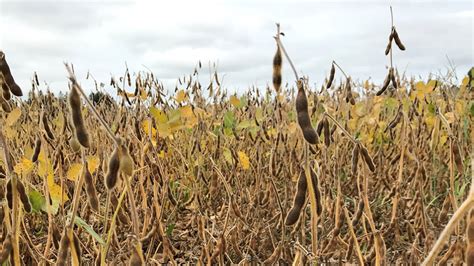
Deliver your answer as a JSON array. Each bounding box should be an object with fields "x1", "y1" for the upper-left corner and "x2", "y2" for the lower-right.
[{"x1": 69, "y1": 85, "x2": 89, "y2": 148}]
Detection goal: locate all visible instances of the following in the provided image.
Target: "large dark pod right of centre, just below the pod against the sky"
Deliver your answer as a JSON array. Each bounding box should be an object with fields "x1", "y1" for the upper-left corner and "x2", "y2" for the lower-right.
[{"x1": 296, "y1": 79, "x2": 318, "y2": 144}]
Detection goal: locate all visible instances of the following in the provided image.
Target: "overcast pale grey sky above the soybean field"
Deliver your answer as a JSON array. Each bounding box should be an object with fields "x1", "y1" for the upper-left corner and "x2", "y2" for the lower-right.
[{"x1": 0, "y1": 0, "x2": 474, "y2": 95}]
